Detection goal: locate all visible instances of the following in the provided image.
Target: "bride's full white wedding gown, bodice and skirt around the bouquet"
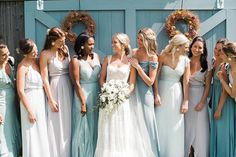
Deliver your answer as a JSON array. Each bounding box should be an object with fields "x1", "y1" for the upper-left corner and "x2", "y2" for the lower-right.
[{"x1": 95, "y1": 56, "x2": 154, "y2": 157}]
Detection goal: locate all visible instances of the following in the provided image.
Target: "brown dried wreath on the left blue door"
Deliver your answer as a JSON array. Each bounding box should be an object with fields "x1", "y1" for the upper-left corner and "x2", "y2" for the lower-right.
[{"x1": 62, "y1": 11, "x2": 96, "y2": 43}]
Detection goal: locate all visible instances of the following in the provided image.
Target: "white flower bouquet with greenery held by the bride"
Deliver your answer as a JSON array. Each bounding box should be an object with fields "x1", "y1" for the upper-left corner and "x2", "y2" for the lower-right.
[{"x1": 98, "y1": 80, "x2": 129, "y2": 115}]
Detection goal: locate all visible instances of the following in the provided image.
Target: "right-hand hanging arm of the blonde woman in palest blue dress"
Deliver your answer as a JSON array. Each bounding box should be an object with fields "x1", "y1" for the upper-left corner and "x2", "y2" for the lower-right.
[{"x1": 180, "y1": 60, "x2": 190, "y2": 113}]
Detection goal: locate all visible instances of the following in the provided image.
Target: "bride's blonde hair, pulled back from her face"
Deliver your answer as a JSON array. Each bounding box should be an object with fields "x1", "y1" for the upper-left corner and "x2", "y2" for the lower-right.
[{"x1": 112, "y1": 33, "x2": 131, "y2": 55}]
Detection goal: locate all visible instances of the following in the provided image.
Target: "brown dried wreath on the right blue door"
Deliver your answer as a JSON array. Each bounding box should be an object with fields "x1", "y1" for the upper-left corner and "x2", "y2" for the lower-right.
[{"x1": 165, "y1": 10, "x2": 200, "y2": 41}]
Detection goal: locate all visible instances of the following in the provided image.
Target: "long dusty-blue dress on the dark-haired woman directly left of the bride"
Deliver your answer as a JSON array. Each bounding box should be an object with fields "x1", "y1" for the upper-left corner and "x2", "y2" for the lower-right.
[{"x1": 72, "y1": 55, "x2": 101, "y2": 157}]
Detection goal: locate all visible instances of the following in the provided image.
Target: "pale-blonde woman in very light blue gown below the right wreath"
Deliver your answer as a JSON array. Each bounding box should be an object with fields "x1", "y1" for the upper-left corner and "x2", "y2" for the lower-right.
[{"x1": 155, "y1": 34, "x2": 190, "y2": 157}]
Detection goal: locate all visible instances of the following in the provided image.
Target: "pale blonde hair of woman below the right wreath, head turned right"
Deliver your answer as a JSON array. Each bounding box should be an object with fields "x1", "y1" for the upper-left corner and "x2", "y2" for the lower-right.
[{"x1": 162, "y1": 34, "x2": 189, "y2": 62}]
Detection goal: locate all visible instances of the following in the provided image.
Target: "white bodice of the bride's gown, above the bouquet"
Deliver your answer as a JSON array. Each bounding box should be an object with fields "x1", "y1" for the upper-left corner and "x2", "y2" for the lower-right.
[{"x1": 106, "y1": 56, "x2": 130, "y2": 82}]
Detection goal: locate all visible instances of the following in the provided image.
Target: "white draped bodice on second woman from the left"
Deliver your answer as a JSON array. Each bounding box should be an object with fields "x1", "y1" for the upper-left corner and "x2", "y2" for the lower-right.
[{"x1": 25, "y1": 66, "x2": 43, "y2": 90}]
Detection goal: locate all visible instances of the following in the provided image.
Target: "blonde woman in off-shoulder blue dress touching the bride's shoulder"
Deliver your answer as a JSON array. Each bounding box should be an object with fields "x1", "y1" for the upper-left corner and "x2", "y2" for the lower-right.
[{"x1": 129, "y1": 28, "x2": 160, "y2": 157}]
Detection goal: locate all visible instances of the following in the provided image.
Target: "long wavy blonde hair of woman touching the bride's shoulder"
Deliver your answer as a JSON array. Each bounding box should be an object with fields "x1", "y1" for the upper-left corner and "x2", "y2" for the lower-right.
[{"x1": 138, "y1": 27, "x2": 157, "y2": 56}]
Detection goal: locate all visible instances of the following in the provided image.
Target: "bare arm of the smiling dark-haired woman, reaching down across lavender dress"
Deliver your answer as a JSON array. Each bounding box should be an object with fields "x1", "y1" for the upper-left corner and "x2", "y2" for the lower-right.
[{"x1": 195, "y1": 70, "x2": 212, "y2": 111}]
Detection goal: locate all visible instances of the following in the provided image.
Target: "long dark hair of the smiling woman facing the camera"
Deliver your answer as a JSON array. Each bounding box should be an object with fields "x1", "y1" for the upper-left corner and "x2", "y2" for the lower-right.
[{"x1": 188, "y1": 36, "x2": 208, "y2": 72}]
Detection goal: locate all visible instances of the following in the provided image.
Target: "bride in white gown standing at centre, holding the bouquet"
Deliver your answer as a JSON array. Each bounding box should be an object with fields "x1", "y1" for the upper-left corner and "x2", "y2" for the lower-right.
[{"x1": 95, "y1": 33, "x2": 154, "y2": 157}]
